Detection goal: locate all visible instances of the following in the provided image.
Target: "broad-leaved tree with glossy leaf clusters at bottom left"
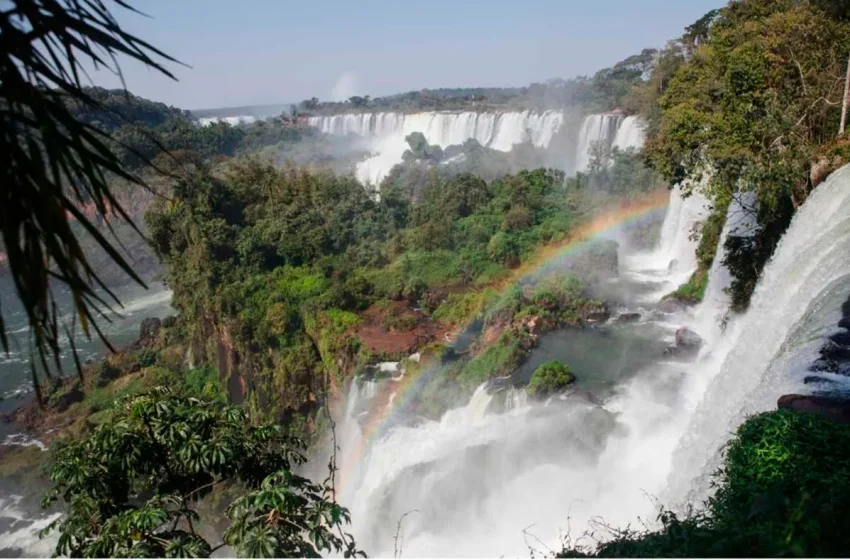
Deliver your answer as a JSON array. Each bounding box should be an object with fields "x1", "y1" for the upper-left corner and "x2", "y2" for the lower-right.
[{"x1": 44, "y1": 387, "x2": 362, "y2": 557}]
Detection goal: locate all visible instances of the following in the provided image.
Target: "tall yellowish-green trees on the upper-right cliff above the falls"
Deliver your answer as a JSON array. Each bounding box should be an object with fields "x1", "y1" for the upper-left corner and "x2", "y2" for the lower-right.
[{"x1": 633, "y1": 0, "x2": 850, "y2": 309}]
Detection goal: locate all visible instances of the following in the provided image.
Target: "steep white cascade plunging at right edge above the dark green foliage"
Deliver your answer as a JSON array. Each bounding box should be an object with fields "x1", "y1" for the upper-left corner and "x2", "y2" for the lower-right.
[{"x1": 668, "y1": 166, "x2": 850, "y2": 501}]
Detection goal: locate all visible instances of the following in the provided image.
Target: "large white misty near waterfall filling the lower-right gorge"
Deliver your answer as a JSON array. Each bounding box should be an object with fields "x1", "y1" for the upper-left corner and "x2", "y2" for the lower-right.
[{"x1": 328, "y1": 167, "x2": 850, "y2": 556}]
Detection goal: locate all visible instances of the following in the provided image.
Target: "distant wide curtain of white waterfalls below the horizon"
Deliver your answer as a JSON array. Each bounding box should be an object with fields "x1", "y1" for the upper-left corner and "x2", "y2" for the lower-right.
[{"x1": 308, "y1": 111, "x2": 643, "y2": 184}]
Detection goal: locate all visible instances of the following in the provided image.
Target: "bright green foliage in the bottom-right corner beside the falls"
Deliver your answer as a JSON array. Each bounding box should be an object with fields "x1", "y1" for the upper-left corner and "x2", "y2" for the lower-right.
[{"x1": 561, "y1": 410, "x2": 850, "y2": 558}]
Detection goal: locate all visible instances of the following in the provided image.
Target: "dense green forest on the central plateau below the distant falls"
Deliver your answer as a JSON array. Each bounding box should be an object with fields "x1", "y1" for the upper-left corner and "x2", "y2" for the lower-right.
[{"x1": 146, "y1": 159, "x2": 596, "y2": 419}]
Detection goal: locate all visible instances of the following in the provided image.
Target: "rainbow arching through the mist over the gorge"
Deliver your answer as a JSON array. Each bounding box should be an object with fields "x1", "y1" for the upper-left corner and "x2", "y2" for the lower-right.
[{"x1": 340, "y1": 190, "x2": 669, "y2": 487}]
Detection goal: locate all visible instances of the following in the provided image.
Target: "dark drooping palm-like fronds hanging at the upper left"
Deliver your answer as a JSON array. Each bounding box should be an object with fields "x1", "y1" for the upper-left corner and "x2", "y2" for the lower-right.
[{"x1": 0, "y1": 0, "x2": 176, "y2": 396}]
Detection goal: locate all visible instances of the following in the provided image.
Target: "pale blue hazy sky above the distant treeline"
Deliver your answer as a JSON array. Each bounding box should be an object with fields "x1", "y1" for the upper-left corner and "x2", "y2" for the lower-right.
[{"x1": 91, "y1": 0, "x2": 725, "y2": 109}]
